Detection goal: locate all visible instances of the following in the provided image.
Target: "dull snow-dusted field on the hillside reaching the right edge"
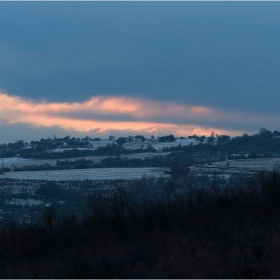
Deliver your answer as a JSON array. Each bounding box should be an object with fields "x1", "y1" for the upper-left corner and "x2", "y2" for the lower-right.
[{"x1": 191, "y1": 158, "x2": 280, "y2": 174}]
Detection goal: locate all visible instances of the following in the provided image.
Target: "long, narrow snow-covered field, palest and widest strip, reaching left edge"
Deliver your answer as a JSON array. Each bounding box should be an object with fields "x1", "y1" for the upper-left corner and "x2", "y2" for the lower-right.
[{"x1": 0, "y1": 167, "x2": 169, "y2": 181}]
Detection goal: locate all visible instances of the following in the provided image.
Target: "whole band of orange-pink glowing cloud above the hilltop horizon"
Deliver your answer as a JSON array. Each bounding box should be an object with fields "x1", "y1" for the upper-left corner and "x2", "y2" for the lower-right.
[{"x1": 0, "y1": 93, "x2": 279, "y2": 136}]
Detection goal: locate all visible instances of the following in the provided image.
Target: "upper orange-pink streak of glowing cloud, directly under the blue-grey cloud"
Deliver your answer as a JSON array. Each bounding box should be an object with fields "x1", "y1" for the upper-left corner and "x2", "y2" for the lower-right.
[{"x1": 0, "y1": 94, "x2": 211, "y2": 119}]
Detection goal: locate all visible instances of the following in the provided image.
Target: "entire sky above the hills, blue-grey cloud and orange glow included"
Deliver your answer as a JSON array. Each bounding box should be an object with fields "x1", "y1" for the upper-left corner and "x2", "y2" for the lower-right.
[{"x1": 0, "y1": 1, "x2": 280, "y2": 143}]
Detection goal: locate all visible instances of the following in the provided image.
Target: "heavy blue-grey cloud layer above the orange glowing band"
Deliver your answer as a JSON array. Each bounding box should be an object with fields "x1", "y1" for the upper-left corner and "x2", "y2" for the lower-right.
[{"x1": 0, "y1": 2, "x2": 280, "y2": 139}]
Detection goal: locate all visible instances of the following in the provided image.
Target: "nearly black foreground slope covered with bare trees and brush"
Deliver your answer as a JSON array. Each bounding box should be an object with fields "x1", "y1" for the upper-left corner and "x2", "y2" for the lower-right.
[{"x1": 0, "y1": 171, "x2": 280, "y2": 278}]
